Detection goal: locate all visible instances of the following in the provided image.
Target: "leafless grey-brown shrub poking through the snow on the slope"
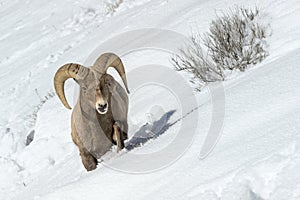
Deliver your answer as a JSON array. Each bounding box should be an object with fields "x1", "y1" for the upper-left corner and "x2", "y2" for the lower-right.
[{"x1": 171, "y1": 8, "x2": 270, "y2": 88}]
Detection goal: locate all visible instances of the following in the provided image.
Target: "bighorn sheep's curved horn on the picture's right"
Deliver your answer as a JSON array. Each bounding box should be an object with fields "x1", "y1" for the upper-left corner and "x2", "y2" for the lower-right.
[{"x1": 92, "y1": 53, "x2": 129, "y2": 94}]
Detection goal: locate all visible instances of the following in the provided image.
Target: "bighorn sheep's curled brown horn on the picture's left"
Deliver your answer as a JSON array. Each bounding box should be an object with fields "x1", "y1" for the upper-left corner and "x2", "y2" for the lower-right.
[{"x1": 54, "y1": 63, "x2": 89, "y2": 109}]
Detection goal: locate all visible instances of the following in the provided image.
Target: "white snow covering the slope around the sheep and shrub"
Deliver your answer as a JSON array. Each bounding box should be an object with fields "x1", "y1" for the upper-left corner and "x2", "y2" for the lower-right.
[{"x1": 0, "y1": 0, "x2": 300, "y2": 200}]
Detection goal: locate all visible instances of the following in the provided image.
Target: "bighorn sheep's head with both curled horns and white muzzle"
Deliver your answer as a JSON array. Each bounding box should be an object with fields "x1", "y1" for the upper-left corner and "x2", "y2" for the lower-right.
[{"x1": 54, "y1": 53, "x2": 129, "y2": 114}]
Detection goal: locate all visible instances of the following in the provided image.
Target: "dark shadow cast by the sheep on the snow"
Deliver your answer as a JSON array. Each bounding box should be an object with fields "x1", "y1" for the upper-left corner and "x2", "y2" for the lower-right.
[{"x1": 125, "y1": 110, "x2": 177, "y2": 151}]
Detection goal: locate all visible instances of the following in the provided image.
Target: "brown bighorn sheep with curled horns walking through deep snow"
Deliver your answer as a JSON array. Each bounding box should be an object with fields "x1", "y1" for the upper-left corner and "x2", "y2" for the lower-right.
[{"x1": 54, "y1": 53, "x2": 129, "y2": 171}]
